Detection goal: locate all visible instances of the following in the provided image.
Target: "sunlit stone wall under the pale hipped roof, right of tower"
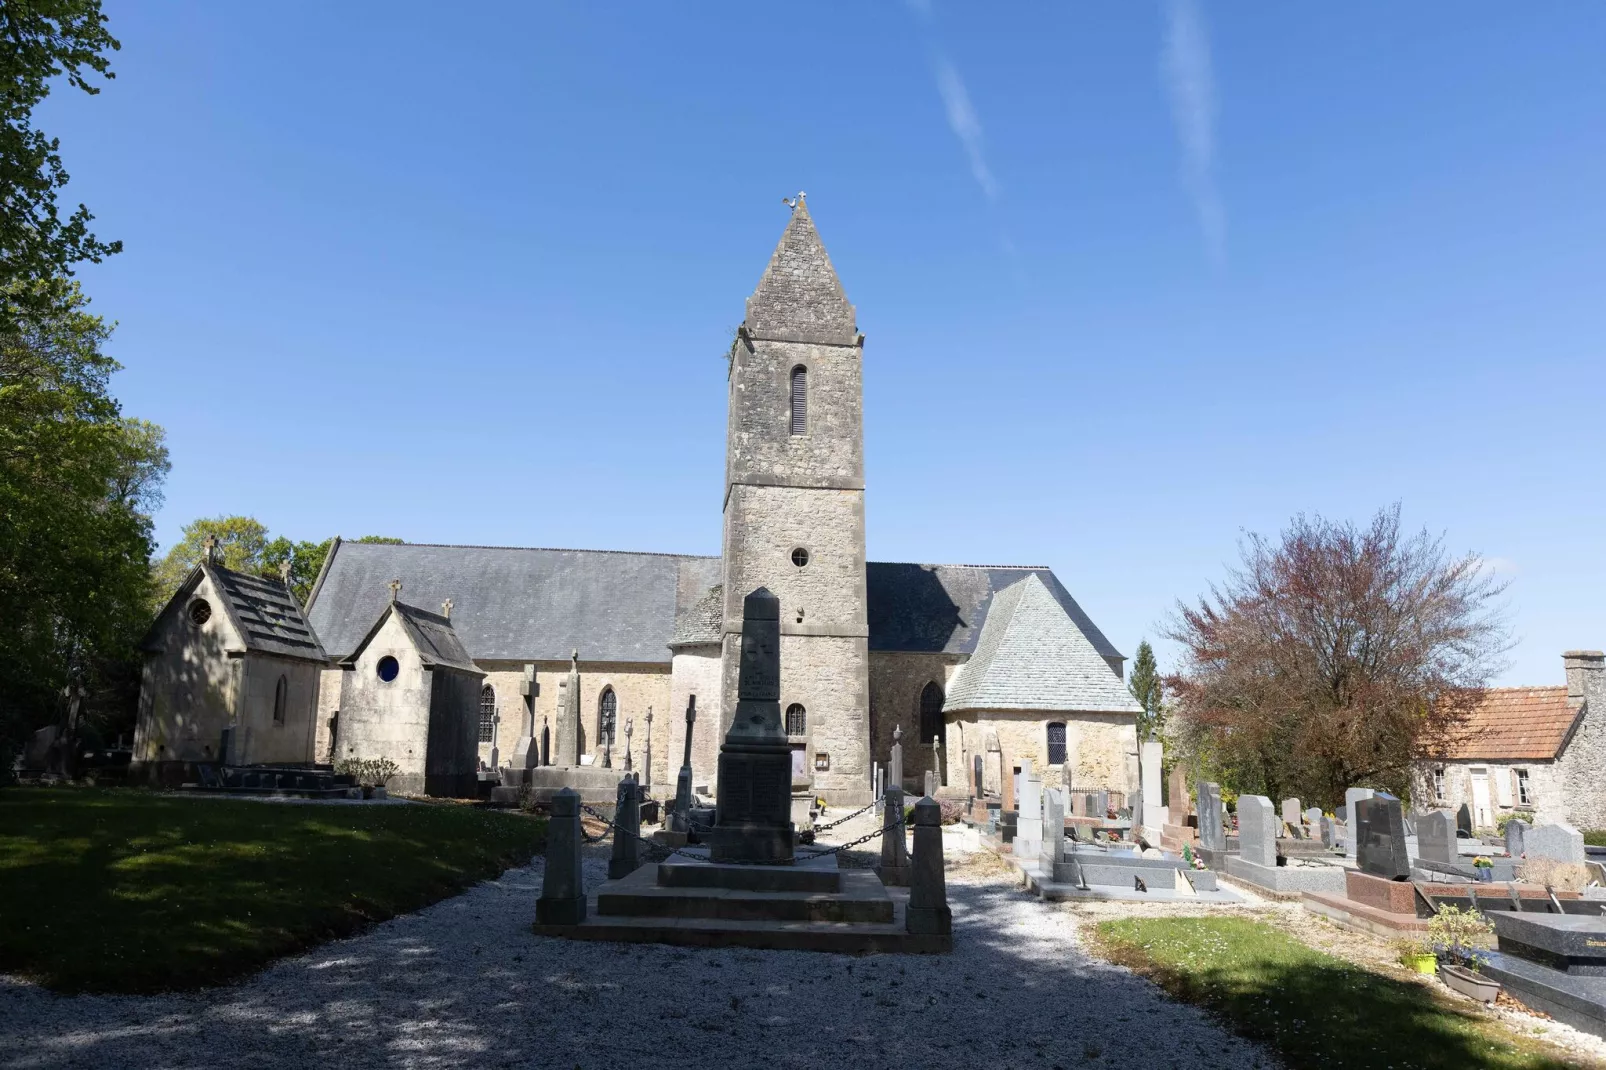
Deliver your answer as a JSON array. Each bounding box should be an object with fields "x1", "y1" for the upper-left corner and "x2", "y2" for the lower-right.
[{"x1": 948, "y1": 710, "x2": 1137, "y2": 792}]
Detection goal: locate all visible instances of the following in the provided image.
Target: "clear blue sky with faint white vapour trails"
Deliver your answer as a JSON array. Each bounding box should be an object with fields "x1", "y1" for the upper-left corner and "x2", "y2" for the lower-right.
[{"x1": 40, "y1": 0, "x2": 1606, "y2": 684}]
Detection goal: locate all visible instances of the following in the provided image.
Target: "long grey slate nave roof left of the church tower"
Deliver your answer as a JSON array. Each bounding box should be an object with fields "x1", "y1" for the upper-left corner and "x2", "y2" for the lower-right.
[{"x1": 307, "y1": 541, "x2": 719, "y2": 662}]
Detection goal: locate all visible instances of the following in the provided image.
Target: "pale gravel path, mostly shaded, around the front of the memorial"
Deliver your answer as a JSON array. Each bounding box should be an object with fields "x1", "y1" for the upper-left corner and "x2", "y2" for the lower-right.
[{"x1": 0, "y1": 822, "x2": 1277, "y2": 1070}]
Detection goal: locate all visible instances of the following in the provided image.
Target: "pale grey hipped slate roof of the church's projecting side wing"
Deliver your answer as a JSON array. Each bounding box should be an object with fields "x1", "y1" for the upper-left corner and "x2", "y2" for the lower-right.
[{"x1": 943, "y1": 574, "x2": 1142, "y2": 713}]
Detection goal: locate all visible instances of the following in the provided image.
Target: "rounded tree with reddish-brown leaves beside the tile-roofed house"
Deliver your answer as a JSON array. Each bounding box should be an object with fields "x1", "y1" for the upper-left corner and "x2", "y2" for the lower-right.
[{"x1": 1166, "y1": 504, "x2": 1510, "y2": 807}]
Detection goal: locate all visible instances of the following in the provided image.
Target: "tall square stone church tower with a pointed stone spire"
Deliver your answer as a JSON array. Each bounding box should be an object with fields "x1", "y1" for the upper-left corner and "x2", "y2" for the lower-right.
[{"x1": 721, "y1": 193, "x2": 870, "y2": 805}]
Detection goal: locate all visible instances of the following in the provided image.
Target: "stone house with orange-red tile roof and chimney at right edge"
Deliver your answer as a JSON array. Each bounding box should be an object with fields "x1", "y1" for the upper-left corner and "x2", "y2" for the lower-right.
[{"x1": 1413, "y1": 651, "x2": 1606, "y2": 829}]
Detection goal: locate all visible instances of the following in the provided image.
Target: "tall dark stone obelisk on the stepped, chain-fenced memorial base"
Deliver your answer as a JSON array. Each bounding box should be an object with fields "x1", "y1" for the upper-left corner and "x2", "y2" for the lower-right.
[{"x1": 708, "y1": 586, "x2": 795, "y2": 864}]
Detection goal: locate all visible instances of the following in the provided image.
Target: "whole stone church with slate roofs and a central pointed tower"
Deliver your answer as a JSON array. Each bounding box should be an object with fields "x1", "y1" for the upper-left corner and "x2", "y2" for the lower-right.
[{"x1": 141, "y1": 194, "x2": 1139, "y2": 805}]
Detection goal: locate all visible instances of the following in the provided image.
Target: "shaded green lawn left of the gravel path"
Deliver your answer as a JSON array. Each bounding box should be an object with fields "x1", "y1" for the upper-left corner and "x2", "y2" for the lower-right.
[{"x1": 0, "y1": 787, "x2": 546, "y2": 993}]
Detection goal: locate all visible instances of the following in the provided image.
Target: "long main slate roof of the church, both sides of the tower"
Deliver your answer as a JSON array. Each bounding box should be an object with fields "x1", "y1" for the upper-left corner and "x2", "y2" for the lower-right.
[{"x1": 307, "y1": 541, "x2": 1124, "y2": 668}]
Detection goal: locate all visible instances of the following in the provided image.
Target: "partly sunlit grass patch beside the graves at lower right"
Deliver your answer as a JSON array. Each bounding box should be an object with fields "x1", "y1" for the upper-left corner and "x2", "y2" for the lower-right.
[{"x1": 1094, "y1": 917, "x2": 1571, "y2": 1070}]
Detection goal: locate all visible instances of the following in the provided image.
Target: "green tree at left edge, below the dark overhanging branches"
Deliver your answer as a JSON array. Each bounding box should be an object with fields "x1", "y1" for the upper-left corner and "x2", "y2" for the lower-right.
[{"x1": 0, "y1": 280, "x2": 167, "y2": 755}]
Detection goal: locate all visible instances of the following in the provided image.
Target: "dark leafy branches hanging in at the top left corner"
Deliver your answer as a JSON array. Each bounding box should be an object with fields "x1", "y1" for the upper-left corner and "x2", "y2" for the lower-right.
[{"x1": 0, "y1": 0, "x2": 122, "y2": 321}]
